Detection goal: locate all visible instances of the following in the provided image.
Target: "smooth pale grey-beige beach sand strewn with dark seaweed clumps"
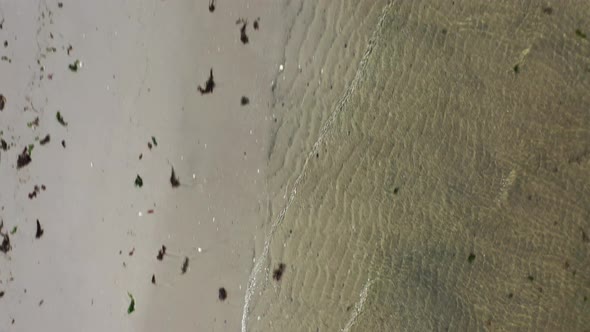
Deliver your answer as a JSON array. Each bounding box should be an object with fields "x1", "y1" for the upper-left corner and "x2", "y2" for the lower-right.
[{"x1": 0, "y1": 1, "x2": 284, "y2": 331}]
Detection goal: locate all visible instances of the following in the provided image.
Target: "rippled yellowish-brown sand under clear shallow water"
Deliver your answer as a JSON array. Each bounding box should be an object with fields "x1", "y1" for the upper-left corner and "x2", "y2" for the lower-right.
[{"x1": 247, "y1": 1, "x2": 590, "y2": 331}]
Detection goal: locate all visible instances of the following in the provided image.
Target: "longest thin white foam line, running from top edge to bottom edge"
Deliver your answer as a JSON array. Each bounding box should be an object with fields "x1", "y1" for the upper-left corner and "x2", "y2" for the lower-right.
[{"x1": 242, "y1": 2, "x2": 391, "y2": 332}]
